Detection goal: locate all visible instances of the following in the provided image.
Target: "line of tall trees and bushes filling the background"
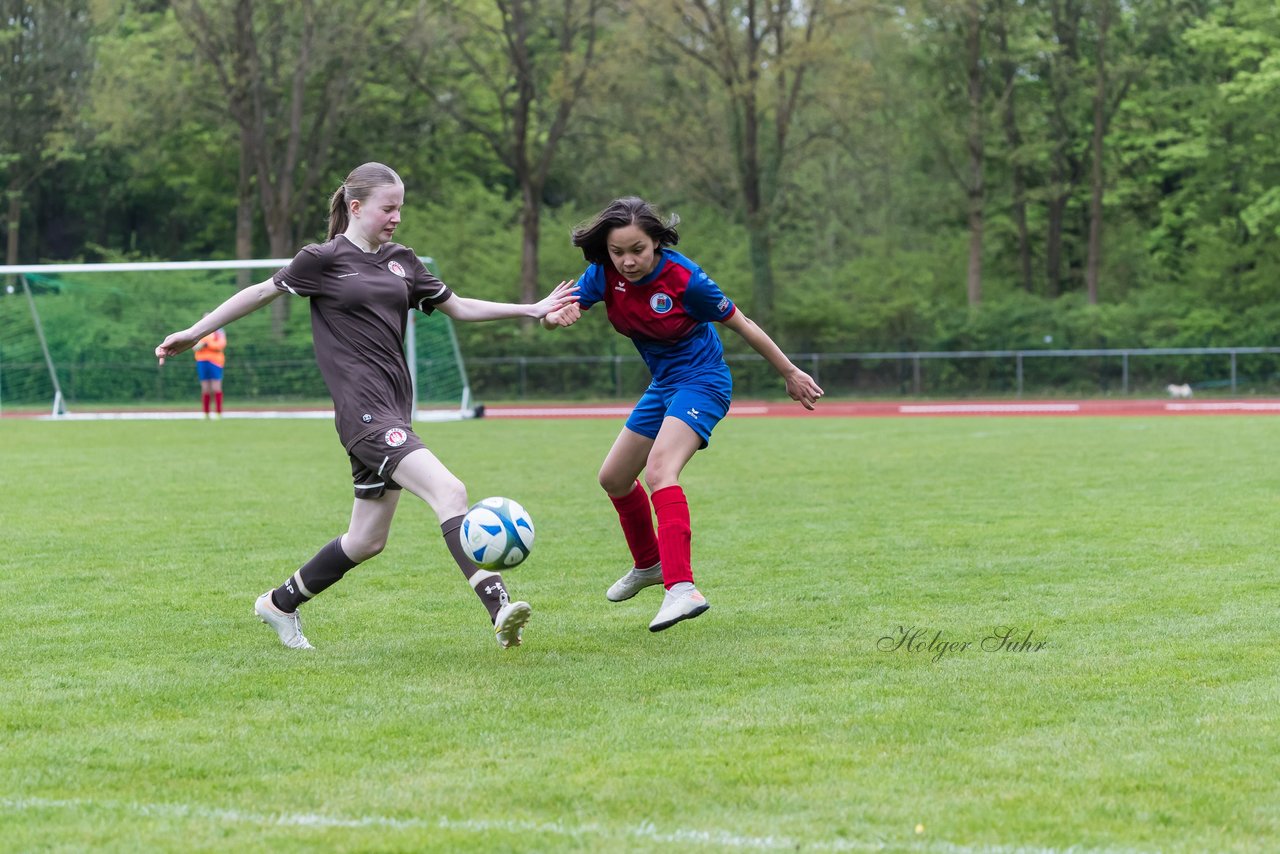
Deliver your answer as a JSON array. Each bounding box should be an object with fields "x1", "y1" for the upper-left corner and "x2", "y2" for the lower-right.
[{"x1": 0, "y1": 0, "x2": 1280, "y2": 361}]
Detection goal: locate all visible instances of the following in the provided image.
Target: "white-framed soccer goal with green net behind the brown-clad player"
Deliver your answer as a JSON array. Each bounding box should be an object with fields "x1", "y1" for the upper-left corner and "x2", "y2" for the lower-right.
[{"x1": 0, "y1": 257, "x2": 483, "y2": 421}]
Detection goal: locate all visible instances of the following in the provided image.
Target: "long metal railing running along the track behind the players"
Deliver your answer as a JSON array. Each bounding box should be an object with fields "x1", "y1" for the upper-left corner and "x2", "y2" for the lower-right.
[{"x1": 0, "y1": 347, "x2": 1280, "y2": 407}]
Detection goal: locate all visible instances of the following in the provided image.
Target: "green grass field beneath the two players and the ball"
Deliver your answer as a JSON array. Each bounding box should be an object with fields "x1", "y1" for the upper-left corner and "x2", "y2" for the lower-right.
[{"x1": 0, "y1": 416, "x2": 1280, "y2": 851}]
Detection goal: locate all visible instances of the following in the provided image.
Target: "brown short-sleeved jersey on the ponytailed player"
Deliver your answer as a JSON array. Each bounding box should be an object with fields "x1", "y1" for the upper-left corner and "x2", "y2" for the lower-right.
[{"x1": 273, "y1": 234, "x2": 453, "y2": 449}]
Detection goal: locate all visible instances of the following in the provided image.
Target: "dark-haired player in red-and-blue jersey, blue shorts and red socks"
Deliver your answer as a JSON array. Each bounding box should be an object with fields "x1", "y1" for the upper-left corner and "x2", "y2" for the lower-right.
[{"x1": 541, "y1": 197, "x2": 822, "y2": 631}]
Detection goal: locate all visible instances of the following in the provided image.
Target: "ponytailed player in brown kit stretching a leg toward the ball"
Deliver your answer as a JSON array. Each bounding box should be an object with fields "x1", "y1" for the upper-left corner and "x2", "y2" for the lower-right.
[{"x1": 156, "y1": 163, "x2": 577, "y2": 649}]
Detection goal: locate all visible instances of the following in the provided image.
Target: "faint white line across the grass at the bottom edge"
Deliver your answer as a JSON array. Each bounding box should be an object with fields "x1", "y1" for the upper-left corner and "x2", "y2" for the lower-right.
[{"x1": 0, "y1": 798, "x2": 1130, "y2": 854}]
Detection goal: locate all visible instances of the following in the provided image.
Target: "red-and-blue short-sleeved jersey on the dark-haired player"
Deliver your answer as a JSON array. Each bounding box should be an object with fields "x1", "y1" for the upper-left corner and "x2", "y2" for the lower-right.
[{"x1": 577, "y1": 248, "x2": 737, "y2": 387}]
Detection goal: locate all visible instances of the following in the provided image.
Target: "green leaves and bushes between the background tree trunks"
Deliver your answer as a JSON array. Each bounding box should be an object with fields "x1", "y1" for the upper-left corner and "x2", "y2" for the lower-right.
[{"x1": 6, "y1": 0, "x2": 1280, "y2": 359}]
